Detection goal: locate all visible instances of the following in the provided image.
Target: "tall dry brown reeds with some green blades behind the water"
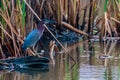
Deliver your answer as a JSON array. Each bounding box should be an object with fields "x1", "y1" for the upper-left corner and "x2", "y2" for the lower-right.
[{"x1": 0, "y1": 0, "x2": 120, "y2": 58}]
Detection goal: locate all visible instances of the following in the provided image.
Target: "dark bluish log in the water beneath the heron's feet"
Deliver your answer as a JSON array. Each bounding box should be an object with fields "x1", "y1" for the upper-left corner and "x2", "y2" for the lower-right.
[{"x1": 0, "y1": 56, "x2": 49, "y2": 70}]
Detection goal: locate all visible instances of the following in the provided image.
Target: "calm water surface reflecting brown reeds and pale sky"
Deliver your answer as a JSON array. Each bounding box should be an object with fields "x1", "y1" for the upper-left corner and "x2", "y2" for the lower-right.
[{"x1": 0, "y1": 41, "x2": 120, "y2": 80}]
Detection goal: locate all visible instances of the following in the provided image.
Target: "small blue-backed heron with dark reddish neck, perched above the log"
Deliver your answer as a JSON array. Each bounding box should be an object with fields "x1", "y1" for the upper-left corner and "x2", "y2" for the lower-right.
[{"x1": 22, "y1": 21, "x2": 45, "y2": 52}]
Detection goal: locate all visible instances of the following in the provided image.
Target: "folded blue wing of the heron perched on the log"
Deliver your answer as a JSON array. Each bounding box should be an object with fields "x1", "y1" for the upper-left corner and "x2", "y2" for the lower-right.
[{"x1": 22, "y1": 29, "x2": 41, "y2": 48}]
